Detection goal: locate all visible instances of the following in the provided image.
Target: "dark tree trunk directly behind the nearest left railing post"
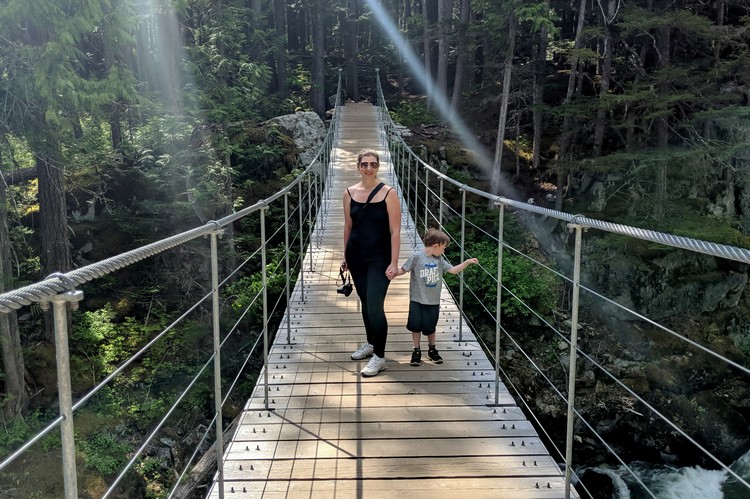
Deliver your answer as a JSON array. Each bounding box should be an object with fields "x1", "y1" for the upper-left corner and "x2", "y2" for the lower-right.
[{"x1": 36, "y1": 153, "x2": 71, "y2": 342}]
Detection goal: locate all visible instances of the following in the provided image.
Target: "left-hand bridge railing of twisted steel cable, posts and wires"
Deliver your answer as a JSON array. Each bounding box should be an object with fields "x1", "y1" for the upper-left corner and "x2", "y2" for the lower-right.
[{"x1": 0, "y1": 71, "x2": 342, "y2": 499}]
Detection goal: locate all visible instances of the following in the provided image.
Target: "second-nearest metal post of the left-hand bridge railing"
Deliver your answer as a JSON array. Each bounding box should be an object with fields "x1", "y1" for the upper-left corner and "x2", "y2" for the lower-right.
[{"x1": 211, "y1": 230, "x2": 224, "y2": 499}]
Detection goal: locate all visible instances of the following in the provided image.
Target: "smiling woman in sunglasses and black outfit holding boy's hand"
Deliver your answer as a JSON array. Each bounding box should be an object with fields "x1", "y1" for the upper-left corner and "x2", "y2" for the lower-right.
[{"x1": 341, "y1": 150, "x2": 401, "y2": 376}]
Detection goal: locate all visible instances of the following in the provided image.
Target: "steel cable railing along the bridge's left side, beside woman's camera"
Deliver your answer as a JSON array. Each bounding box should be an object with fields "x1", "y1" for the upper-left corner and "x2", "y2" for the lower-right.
[{"x1": 0, "y1": 71, "x2": 342, "y2": 499}]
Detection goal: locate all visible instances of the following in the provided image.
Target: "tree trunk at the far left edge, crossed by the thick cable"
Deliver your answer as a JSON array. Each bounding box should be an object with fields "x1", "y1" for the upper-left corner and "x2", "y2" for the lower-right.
[{"x1": 0, "y1": 158, "x2": 29, "y2": 421}]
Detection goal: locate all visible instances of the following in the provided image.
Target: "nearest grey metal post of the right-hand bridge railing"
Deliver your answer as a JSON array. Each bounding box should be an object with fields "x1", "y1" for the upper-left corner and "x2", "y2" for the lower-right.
[{"x1": 565, "y1": 223, "x2": 584, "y2": 499}]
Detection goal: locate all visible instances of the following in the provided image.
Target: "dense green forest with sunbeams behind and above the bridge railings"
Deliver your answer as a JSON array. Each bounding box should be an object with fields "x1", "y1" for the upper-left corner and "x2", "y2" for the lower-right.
[{"x1": 0, "y1": 0, "x2": 750, "y2": 497}]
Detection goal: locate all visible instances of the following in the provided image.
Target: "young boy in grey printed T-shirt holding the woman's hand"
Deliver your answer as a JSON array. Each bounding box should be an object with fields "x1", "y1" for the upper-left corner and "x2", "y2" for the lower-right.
[{"x1": 398, "y1": 229, "x2": 479, "y2": 367}]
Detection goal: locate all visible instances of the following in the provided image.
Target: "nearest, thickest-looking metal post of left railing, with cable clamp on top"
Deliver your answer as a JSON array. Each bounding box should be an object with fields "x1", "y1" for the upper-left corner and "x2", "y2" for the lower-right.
[{"x1": 41, "y1": 290, "x2": 83, "y2": 499}]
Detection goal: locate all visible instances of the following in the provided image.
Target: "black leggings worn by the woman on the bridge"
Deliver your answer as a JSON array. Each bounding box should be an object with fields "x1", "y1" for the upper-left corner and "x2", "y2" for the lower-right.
[{"x1": 347, "y1": 259, "x2": 391, "y2": 359}]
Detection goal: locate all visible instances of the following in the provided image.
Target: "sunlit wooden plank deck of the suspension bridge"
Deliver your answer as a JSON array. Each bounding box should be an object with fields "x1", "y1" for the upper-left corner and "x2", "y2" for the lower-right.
[{"x1": 209, "y1": 103, "x2": 577, "y2": 499}]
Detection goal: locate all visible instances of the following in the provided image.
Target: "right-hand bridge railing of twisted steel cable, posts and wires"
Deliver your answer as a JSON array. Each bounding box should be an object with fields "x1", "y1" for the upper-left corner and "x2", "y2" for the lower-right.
[{"x1": 376, "y1": 68, "x2": 750, "y2": 497}]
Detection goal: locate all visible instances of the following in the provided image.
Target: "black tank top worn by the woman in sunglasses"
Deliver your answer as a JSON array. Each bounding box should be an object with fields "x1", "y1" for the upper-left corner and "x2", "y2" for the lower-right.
[{"x1": 346, "y1": 189, "x2": 391, "y2": 263}]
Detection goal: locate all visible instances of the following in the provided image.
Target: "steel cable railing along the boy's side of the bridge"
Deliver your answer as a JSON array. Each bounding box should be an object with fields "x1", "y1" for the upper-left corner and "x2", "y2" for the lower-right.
[{"x1": 377, "y1": 68, "x2": 750, "y2": 497}]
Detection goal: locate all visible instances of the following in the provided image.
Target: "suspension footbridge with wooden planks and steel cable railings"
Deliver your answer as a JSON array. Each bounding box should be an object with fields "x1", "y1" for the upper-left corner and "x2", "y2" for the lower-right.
[{"x1": 0, "y1": 75, "x2": 750, "y2": 498}]
